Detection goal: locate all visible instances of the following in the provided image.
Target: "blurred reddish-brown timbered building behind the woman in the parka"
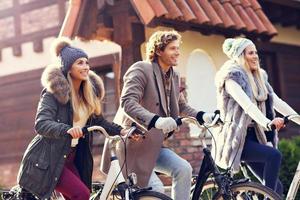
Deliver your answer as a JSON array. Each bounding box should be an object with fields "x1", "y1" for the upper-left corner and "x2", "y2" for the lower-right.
[{"x1": 0, "y1": 0, "x2": 120, "y2": 187}]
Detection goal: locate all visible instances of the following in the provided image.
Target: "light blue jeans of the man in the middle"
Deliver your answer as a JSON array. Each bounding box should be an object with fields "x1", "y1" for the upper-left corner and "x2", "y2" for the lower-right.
[{"x1": 149, "y1": 148, "x2": 192, "y2": 200}]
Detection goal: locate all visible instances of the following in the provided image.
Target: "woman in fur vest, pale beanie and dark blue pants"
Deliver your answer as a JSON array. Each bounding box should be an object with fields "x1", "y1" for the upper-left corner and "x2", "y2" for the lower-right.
[{"x1": 213, "y1": 38, "x2": 300, "y2": 195}]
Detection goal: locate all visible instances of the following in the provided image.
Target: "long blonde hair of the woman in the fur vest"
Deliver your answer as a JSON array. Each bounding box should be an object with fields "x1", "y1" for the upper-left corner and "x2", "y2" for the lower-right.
[{"x1": 236, "y1": 53, "x2": 268, "y2": 101}]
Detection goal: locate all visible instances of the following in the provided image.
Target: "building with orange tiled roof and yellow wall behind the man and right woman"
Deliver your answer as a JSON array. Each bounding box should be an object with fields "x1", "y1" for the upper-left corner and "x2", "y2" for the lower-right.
[{"x1": 62, "y1": 0, "x2": 300, "y2": 173}]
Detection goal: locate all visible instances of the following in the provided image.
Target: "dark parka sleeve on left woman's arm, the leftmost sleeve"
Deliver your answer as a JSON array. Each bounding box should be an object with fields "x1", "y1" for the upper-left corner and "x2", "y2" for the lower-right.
[{"x1": 34, "y1": 92, "x2": 71, "y2": 138}]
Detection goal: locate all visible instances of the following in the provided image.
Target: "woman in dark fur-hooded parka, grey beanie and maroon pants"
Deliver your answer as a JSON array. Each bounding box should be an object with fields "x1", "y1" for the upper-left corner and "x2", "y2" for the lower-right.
[{"x1": 18, "y1": 38, "x2": 127, "y2": 200}]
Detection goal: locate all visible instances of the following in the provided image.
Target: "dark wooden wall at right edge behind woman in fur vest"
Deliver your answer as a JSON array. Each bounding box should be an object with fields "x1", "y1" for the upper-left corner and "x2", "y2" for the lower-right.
[{"x1": 257, "y1": 43, "x2": 300, "y2": 137}]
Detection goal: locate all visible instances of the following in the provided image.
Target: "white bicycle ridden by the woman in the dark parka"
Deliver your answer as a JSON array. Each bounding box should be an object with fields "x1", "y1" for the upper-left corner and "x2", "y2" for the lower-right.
[{"x1": 2, "y1": 126, "x2": 171, "y2": 200}]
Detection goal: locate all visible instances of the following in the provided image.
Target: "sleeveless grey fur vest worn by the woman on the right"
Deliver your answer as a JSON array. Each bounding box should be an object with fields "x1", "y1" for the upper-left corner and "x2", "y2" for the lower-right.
[{"x1": 212, "y1": 60, "x2": 278, "y2": 173}]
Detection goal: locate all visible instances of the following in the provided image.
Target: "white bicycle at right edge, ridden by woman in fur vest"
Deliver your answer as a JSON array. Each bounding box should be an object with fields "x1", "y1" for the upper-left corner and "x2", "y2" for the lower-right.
[{"x1": 241, "y1": 114, "x2": 300, "y2": 200}]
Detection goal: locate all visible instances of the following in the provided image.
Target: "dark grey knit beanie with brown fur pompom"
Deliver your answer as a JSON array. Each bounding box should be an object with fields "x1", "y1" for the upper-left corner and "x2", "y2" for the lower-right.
[{"x1": 54, "y1": 37, "x2": 88, "y2": 77}]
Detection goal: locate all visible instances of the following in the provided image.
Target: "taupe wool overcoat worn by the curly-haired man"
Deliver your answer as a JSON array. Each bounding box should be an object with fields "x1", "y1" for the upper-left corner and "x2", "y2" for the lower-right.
[{"x1": 101, "y1": 61, "x2": 197, "y2": 187}]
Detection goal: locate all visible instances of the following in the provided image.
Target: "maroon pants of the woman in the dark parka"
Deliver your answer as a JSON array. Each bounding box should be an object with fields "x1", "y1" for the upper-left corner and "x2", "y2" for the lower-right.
[{"x1": 55, "y1": 150, "x2": 90, "y2": 200}]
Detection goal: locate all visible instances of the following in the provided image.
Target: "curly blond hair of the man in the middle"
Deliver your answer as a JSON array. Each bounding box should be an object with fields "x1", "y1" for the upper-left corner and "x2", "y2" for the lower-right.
[{"x1": 146, "y1": 30, "x2": 181, "y2": 61}]
